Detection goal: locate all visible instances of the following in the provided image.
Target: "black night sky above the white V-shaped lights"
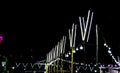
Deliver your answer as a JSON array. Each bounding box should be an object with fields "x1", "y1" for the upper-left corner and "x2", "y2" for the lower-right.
[{"x1": 0, "y1": 0, "x2": 120, "y2": 63}]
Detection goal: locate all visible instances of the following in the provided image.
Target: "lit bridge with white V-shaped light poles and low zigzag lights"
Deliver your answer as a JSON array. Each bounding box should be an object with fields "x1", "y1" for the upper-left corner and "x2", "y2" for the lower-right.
[{"x1": 3, "y1": 10, "x2": 120, "y2": 73}]
